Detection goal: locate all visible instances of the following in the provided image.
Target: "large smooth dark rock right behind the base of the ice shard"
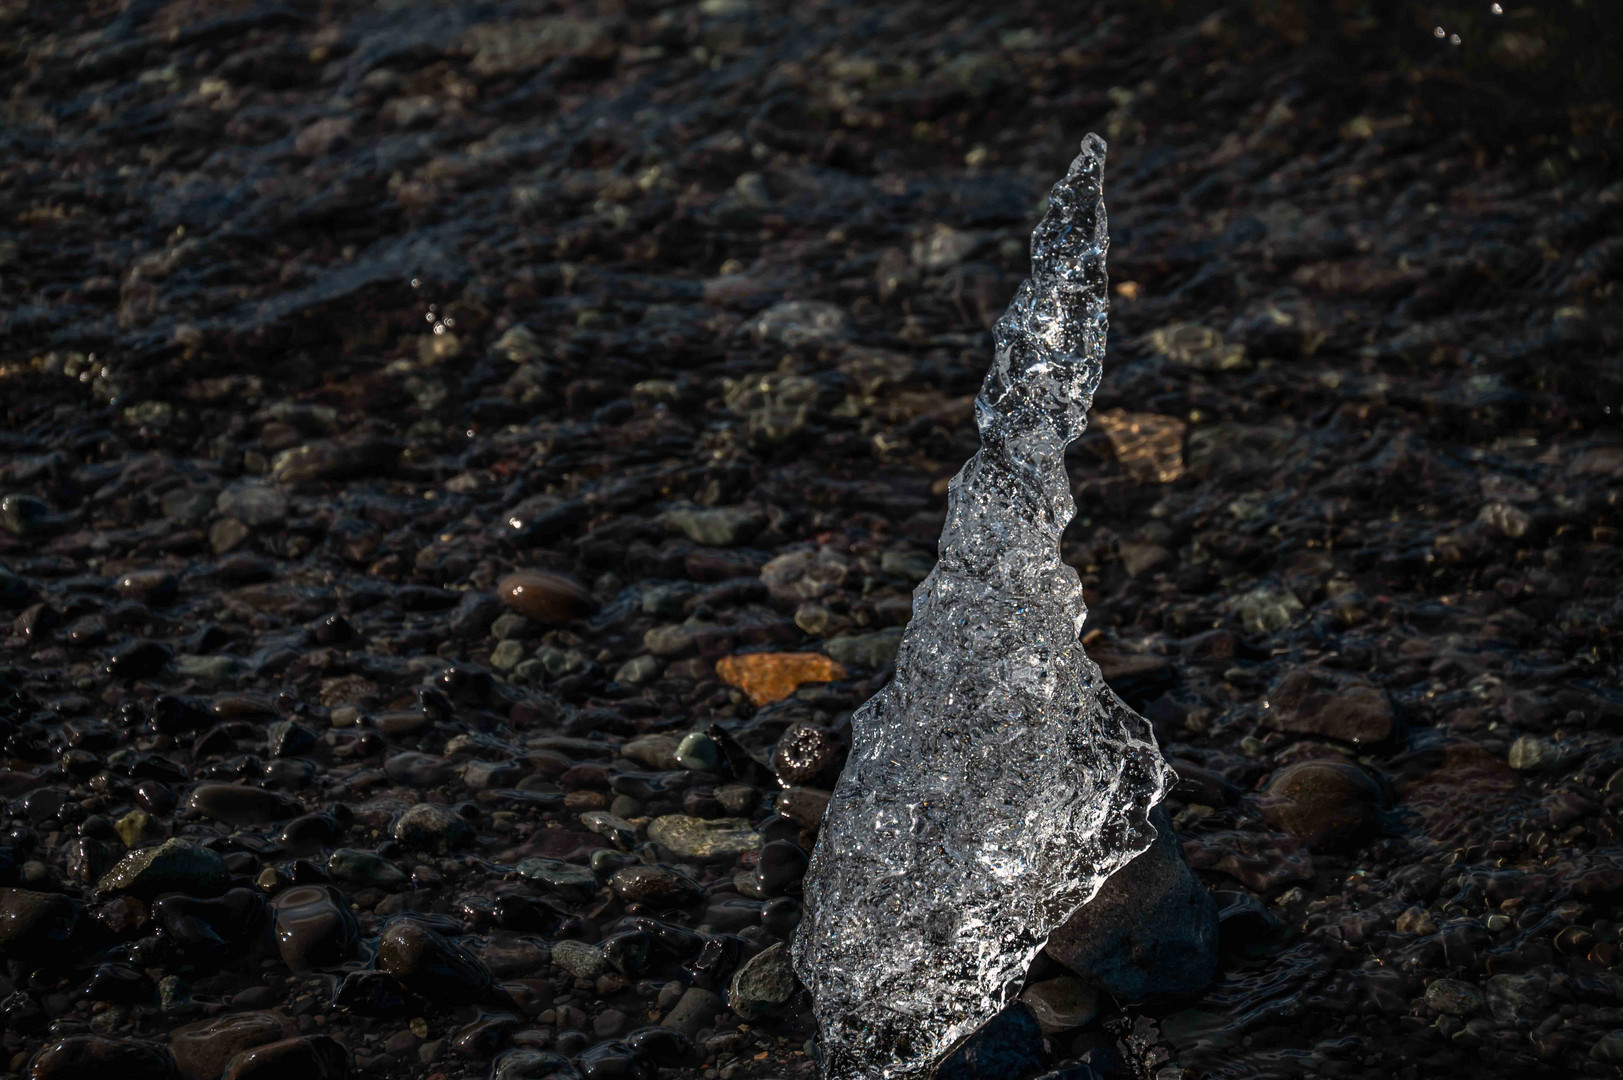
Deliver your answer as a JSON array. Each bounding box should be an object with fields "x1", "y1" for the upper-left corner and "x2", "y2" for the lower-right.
[{"x1": 1047, "y1": 807, "x2": 1217, "y2": 1000}]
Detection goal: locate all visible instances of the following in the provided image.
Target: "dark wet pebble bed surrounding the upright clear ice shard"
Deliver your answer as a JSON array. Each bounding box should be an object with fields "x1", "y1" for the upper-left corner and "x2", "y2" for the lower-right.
[{"x1": 0, "y1": 0, "x2": 1623, "y2": 1080}]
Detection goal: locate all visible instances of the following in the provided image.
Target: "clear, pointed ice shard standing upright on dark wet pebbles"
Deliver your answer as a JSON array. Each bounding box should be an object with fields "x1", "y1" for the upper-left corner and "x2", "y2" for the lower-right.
[{"x1": 794, "y1": 135, "x2": 1172, "y2": 1080}]
